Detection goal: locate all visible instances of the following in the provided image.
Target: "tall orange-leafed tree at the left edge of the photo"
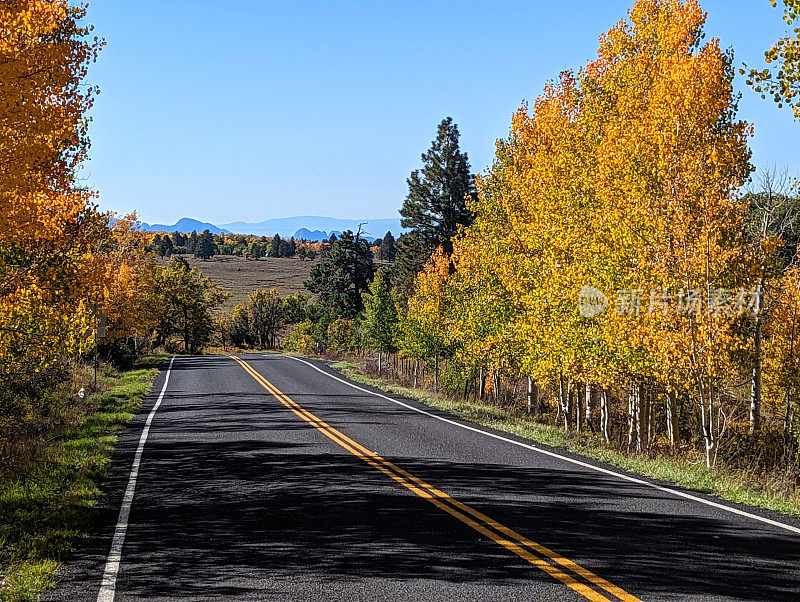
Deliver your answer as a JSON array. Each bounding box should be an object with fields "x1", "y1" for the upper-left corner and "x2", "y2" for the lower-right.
[{"x1": 0, "y1": 0, "x2": 107, "y2": 374}]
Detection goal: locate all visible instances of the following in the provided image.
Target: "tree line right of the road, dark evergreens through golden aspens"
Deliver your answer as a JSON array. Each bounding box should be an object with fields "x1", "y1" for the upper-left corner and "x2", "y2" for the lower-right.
[{"x1": 268, "y1": 0, "x2": 800, "y2": 473}]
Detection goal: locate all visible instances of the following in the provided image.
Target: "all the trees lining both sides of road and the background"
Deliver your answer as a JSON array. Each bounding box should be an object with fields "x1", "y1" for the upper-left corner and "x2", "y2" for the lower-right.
[{"x1": 0, "y1": 0, "x2": 800, "y2": 482}]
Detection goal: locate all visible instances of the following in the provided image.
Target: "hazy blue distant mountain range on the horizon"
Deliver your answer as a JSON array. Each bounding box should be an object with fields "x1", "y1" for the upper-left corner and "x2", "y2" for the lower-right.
[{"x1": 142, "y1": 215, "x2": 403, "y2": 240}]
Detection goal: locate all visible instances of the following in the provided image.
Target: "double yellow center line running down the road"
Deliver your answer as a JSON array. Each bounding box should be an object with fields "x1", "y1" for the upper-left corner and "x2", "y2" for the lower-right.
[{"x1": 231, "y1": 356, "x2": 639, "y2": 602}]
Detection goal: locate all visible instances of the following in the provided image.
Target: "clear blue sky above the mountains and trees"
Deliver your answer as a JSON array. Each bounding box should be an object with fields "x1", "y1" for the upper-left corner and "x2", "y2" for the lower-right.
[{"x1": 82, "y1": 0, "x2": 800, "y2": 223}]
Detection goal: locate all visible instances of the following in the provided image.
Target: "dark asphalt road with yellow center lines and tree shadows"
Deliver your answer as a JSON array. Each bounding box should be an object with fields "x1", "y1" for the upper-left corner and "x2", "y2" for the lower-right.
[{"x1": 45, "y1": 354, "x2": 800, "y2": 601}]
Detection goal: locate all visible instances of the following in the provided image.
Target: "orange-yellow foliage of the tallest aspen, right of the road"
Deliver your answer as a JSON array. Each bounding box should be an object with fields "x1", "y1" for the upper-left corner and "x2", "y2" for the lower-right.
[{"x1": 583, "y1": 0, "x2": 751, "y2": 389}]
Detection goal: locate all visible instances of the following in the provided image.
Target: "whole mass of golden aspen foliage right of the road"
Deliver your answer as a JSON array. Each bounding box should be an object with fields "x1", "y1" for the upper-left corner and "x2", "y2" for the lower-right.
[{"x1": 418, "y1": 0, "x2": 764, "y2": 460}]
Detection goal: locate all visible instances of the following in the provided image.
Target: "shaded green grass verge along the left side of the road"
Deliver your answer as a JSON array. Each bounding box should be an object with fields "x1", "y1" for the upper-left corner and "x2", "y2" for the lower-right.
[{"x1": 0, "y1": 357, "x2": 163, "y2": 601}]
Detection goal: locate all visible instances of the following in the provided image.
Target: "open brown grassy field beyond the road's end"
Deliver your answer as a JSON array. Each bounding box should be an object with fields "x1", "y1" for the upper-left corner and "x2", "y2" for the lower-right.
[{"x1": 175, "y1": 255, "x2": 315, "y2": 312}]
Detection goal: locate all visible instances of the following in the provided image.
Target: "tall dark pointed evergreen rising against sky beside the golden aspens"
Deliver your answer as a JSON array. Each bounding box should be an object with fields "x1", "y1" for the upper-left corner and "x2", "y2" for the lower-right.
[{"x1": 397, "y1": 117, "x2": 476, "y2": 293}]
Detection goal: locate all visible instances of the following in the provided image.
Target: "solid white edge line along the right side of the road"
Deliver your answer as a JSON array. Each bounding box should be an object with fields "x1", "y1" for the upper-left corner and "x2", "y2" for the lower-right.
[{"x1": 285, "y1": 355, "x2": 800, "y2": 534}]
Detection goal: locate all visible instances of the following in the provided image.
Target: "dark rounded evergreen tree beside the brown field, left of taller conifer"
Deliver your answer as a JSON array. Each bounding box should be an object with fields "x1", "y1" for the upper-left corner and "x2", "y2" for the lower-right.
[{"x1": 304, "y1": 230, "x2": 374, "y2": 318}]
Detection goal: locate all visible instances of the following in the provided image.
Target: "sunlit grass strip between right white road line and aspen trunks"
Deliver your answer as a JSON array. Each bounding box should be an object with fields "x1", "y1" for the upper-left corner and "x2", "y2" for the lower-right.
[{"x1": 333, "y1": 361, "x2": 800, "y2": 516}]
